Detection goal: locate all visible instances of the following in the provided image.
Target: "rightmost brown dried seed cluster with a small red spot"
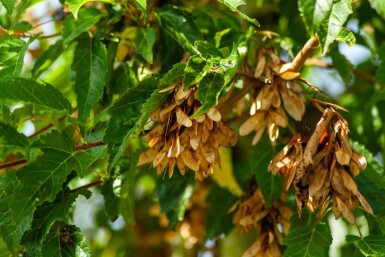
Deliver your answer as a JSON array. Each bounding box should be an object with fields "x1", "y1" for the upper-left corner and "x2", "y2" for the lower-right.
[{"x1": 268, "y1": 108, "x2": 373, "y2": 224}]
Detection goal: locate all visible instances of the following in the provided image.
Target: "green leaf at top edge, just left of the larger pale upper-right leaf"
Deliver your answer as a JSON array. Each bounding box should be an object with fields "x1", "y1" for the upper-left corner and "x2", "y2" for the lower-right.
[{"x1": 298, "y1": 0, "x2": 333, "y2": 36}]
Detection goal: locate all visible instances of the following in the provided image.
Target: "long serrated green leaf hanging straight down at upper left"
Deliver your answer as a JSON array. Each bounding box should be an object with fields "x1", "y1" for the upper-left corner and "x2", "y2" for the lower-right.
[{"x1": 72, "y1": 38, "x2": 107, "y2": 121}]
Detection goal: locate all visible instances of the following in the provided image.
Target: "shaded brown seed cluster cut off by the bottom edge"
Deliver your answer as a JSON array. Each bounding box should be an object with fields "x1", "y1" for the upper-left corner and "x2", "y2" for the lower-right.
[{"x1": 233, "y1": 187, "x2": 292, "y2": 257}]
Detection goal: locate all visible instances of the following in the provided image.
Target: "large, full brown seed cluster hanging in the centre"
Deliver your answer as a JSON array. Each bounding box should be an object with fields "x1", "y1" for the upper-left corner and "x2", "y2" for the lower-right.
[{"x1": 138, "y1": 82, "x2": 237, "y2": 180}]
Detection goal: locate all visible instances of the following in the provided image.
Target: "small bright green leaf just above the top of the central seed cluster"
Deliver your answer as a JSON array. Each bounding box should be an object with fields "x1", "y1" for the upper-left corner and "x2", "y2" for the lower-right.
[{"x1": 183, "y1": 55, "x2": 206, "y2": 89}]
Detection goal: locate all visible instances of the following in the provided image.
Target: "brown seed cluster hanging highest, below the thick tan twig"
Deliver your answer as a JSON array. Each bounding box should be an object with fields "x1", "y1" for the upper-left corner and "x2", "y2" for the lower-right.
[{"x1": 239, "y1": 49, "x2": 305, "y2": 145}]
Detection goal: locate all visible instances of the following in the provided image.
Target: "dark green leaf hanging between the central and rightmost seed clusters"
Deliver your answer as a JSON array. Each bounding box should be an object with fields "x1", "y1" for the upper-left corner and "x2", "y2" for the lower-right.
[{"x1": 251, "y1": 138, "x2": 284, "y2": 207}]
